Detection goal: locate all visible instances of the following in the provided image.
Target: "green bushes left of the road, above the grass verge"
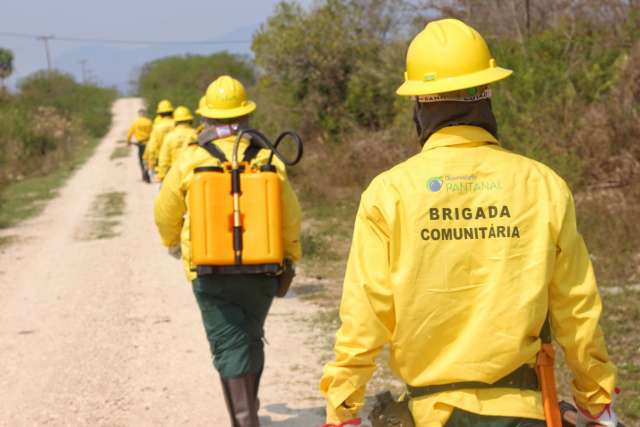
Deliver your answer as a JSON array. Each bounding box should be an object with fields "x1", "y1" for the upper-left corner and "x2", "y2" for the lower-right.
[{"x1": 0, "y1": 72, "x2": 116, "y2": 189}]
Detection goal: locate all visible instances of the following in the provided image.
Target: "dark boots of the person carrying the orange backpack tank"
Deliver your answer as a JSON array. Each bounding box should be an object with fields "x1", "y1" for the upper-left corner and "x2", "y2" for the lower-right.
[{"x1": 222, "y1": 374, "x2": 260, "y2": 427}]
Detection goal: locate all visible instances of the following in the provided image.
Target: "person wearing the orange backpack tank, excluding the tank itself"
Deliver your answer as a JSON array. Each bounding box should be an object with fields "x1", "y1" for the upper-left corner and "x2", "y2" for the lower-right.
[{"x1": 155, "y1": 76, "x2": 301, "y2": 427}]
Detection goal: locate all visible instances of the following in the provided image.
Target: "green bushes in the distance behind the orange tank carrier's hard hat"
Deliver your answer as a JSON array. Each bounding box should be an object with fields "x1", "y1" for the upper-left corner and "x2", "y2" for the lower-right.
[{"x1": 138, "y1": 52, "x2": 254, "y2": 117}]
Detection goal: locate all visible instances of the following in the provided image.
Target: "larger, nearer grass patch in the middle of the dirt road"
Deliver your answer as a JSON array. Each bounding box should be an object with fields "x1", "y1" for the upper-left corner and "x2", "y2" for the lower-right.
[{"x1": 76, "y1": 191, "x2": 126, "y2": 240}]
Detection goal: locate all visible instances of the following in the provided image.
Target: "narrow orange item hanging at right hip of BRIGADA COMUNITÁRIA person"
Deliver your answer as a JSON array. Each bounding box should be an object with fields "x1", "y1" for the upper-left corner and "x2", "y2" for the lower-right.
[{"x1": 536, "y1": 318, "x2": 562, "y2": 427}]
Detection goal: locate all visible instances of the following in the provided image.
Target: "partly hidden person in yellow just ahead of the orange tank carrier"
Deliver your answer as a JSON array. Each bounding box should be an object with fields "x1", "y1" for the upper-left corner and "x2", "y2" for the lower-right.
[{"x1": 156, "y1": 106, "x2": 198, "y2": 181}]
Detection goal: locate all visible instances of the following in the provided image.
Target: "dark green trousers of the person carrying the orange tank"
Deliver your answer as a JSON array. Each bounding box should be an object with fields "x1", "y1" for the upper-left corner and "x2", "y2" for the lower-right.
[{"x1": 193, "y1": 274, "x2": 278, "y2": 378}]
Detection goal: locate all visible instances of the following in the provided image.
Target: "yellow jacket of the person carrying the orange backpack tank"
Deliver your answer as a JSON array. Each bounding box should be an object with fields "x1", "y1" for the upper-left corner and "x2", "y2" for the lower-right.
[{"x1": 155, "y1": 136, "x2": 301, "y2": 280}]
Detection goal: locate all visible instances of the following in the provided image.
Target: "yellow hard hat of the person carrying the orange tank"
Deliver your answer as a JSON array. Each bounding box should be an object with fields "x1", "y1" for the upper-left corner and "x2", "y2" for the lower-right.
[{"x1": 198, "y1": 76, "x2": 256, "y2": 119}]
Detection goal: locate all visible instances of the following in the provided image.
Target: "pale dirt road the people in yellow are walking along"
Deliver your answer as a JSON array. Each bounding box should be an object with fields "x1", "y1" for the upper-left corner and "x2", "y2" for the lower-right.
[{"x1": 0, "y1": 99, "x2": 323, "y2": 427}]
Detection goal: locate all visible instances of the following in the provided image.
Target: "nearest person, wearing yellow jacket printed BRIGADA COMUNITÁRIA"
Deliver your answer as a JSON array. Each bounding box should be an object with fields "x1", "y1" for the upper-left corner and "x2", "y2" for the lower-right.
[{"x1": 320, "y1": 19, "x2": 616, "y2": 427}]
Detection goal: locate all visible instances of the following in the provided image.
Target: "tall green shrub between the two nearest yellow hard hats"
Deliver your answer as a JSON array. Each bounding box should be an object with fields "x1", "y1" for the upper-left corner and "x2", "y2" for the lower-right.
[{"x1": 252, "y1": 0, "x2": 404, "y2": 139}]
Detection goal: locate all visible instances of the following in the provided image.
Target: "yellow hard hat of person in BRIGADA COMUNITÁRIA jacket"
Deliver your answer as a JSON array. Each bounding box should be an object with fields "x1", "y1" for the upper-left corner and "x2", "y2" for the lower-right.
[{"x1": 396, "y1": 19, "x2": 513, "y2": 96}]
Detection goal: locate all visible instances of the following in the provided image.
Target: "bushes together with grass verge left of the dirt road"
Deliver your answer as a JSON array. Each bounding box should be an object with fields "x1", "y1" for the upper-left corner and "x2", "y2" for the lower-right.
[{"x1": 0, "y1": 67, "x2": 116, "y2": 228}]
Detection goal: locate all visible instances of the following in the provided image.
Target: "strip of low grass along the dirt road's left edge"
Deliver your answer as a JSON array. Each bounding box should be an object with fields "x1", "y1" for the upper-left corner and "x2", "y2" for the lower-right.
[{"x1": 0, "y1": 138, "x2": 100, "y2": 229}]
